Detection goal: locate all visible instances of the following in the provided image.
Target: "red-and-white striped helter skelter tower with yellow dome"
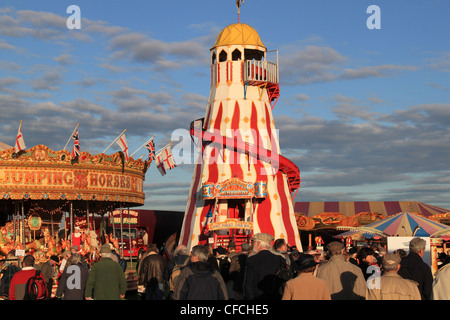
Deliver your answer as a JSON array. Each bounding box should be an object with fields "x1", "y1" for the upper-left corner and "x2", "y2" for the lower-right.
[{"x1": 179, "y1": 23, "x2": 302, "y2": 250}]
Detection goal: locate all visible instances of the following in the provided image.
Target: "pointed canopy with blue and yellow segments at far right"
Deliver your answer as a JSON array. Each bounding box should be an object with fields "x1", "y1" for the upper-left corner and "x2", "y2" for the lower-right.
[{"x1": 337, "y1": 212, "x2": 449, "y2": 239}]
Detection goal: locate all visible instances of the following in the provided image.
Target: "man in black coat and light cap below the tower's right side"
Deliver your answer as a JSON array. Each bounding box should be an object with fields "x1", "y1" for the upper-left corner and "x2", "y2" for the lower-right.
[{"x1": 244, "y1": 233, "x2": 285, "y2": 300}]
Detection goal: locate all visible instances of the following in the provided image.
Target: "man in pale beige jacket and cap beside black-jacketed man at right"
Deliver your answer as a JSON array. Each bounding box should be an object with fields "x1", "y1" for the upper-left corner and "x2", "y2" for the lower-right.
[{"x1": 368, "y1": 253, "x2": 421, "y2": 300}]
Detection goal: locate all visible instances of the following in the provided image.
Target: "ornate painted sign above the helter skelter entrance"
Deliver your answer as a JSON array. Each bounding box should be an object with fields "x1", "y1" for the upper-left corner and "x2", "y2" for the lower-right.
[{"x1": 203, "y1": 178, "x2": 267, "y2": 200}]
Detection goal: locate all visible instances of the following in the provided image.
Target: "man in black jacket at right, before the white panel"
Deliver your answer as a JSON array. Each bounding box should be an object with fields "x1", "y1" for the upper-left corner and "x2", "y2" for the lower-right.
[{"x1": 398, "y1": 238, "x2": 433, "y2": 300}]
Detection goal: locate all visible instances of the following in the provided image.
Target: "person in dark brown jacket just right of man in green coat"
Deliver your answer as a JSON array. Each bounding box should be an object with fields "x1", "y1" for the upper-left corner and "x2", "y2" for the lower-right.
[{"x1": 138, "y1": 244, "x2": 167, "y2": 300}]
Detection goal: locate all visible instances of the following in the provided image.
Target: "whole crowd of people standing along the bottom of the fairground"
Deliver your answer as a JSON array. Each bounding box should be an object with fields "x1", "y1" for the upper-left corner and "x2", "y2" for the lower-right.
[{"x1": 0, "y1": 233, "x2": 450, "y2": 301}]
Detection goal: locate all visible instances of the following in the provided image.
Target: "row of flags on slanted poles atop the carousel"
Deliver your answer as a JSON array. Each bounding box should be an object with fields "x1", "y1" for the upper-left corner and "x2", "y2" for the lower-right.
[{"x1": 10, "y1": 120, "x2": 177, "y2": 176}]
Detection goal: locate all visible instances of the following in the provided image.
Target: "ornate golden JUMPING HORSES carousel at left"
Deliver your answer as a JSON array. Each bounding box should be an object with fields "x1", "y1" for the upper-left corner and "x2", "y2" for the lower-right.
[{"x1": 0, "y1": 145, "x2": 152, "y2": 257}]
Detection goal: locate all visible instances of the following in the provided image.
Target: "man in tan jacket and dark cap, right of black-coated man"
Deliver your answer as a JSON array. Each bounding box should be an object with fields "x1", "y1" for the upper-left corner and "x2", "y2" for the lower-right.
[{"x1": 282, "y1": 253, "x2": 331, "y2": 300}]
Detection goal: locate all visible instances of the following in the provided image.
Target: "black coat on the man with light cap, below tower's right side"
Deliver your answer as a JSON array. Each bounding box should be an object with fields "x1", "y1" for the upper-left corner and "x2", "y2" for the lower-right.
[{"x1": 244, "y1": 250, "x2": 286, "y2": 300}]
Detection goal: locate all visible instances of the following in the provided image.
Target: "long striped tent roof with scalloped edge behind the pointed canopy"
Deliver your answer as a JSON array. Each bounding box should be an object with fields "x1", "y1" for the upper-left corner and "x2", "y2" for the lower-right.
[{"x1": 294, "y1": 201, "x2": 450, "y2": 217}]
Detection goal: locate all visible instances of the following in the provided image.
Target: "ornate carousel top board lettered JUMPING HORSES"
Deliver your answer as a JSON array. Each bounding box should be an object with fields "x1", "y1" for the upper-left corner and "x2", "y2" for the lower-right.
[{"x1": 0, "y1": 145, "x2": 149, "y2": 204}]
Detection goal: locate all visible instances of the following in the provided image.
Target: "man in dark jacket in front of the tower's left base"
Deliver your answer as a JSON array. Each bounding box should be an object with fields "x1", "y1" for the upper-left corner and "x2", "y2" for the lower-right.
[{"x1": 173, "y1": 245, "x2": 228, "y2": 300}]
